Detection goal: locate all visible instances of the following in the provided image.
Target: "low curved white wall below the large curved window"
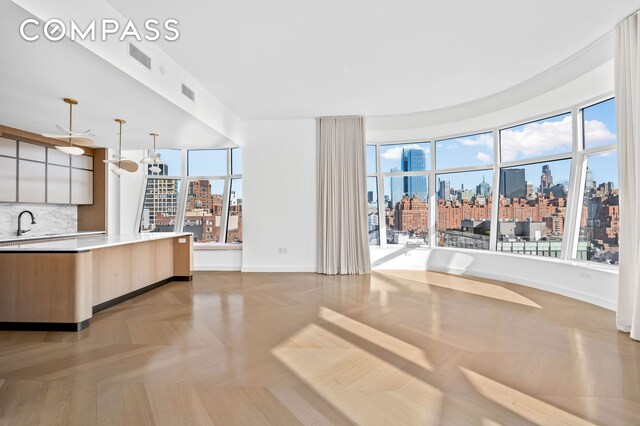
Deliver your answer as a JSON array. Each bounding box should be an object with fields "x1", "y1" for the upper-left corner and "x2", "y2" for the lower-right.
[{"x1": 371, "y1": 246, "x2": 618, "y2": 309}]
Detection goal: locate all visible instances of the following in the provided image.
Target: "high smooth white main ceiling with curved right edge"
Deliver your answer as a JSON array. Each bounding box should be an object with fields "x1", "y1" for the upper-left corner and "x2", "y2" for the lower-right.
[{"x1": 108, "y1": 0, "x2": 640, "y2": 120}]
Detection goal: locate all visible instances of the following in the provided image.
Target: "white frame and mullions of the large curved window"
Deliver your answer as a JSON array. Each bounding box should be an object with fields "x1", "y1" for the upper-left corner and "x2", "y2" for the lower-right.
[{"x1": 366, "y1": 92, "x2": 619, "y2": 270}]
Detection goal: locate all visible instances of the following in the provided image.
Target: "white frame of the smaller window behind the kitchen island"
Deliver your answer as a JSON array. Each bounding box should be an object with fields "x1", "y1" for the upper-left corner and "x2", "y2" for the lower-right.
[{"x1": 134, "y1": 147, "x2": 242, "y2": 249}]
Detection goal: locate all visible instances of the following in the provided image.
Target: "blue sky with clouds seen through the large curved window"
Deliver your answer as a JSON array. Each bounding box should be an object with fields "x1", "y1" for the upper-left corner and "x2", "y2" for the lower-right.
[{"x1": 367, "y1": 99, "x2": 618, "y2": 191}]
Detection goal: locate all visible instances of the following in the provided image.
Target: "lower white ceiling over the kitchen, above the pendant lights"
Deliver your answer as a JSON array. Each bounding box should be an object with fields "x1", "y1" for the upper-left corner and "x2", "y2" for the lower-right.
[{"x1": 0, "y1": 1, "x2": 233, "y2": 149}]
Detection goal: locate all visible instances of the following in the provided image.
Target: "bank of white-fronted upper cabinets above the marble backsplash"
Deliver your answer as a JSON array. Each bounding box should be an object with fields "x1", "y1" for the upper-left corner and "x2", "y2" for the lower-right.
[{"x1": 0, "y1": 138, "x2": 93, "y2": 205}]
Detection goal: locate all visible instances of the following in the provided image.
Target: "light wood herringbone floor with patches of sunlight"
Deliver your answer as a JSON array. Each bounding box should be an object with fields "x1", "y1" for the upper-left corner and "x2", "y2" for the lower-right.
[{"x1": 0, "y1": 271, "x2": 640, "y2": 425}]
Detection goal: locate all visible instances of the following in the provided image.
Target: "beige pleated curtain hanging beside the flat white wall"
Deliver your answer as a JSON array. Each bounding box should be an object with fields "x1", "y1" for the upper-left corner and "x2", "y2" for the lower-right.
[{"x1": 317, "y1": 117, "x2": 371, "y2": 274}]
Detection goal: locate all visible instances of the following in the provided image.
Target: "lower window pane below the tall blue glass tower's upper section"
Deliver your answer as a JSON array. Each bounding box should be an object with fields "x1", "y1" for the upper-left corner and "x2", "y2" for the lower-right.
[{"x1": 384, "y1": 176, "x2": 429, "y2": 244}]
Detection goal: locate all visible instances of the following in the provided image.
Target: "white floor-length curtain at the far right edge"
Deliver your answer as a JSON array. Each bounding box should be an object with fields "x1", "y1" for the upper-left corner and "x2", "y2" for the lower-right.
[{"x1": 615, "y1": 12, "x2": 640, "y2": 340}]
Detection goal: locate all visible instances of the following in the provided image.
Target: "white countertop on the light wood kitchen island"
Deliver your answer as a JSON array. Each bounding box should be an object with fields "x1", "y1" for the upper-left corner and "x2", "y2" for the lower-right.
[{"x1": 0, "y1": 232, "x2": 191, "y2": 253}]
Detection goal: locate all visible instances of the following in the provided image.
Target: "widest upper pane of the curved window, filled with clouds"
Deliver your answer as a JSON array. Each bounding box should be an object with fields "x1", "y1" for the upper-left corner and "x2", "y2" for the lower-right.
[{"x1": 500, "y1": 113, "x2": 573, "y2": 162}]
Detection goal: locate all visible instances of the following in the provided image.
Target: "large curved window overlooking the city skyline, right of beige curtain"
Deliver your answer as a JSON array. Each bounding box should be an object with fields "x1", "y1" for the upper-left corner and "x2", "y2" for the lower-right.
[{"x1": 367, "y1": 99, "x2": 620, "y2": 264}]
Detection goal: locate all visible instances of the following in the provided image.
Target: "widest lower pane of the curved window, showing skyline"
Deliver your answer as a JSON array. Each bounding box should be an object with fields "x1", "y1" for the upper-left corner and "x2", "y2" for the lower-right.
[{"x1": 497, "y1": 159, "x2": 571, "y2": 257}]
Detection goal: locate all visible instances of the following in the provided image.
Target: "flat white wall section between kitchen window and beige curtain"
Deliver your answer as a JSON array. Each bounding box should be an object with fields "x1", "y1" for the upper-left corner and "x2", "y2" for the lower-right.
[{"x1": 242, "y1": 119, "x2": 317, "y2": 272}]
